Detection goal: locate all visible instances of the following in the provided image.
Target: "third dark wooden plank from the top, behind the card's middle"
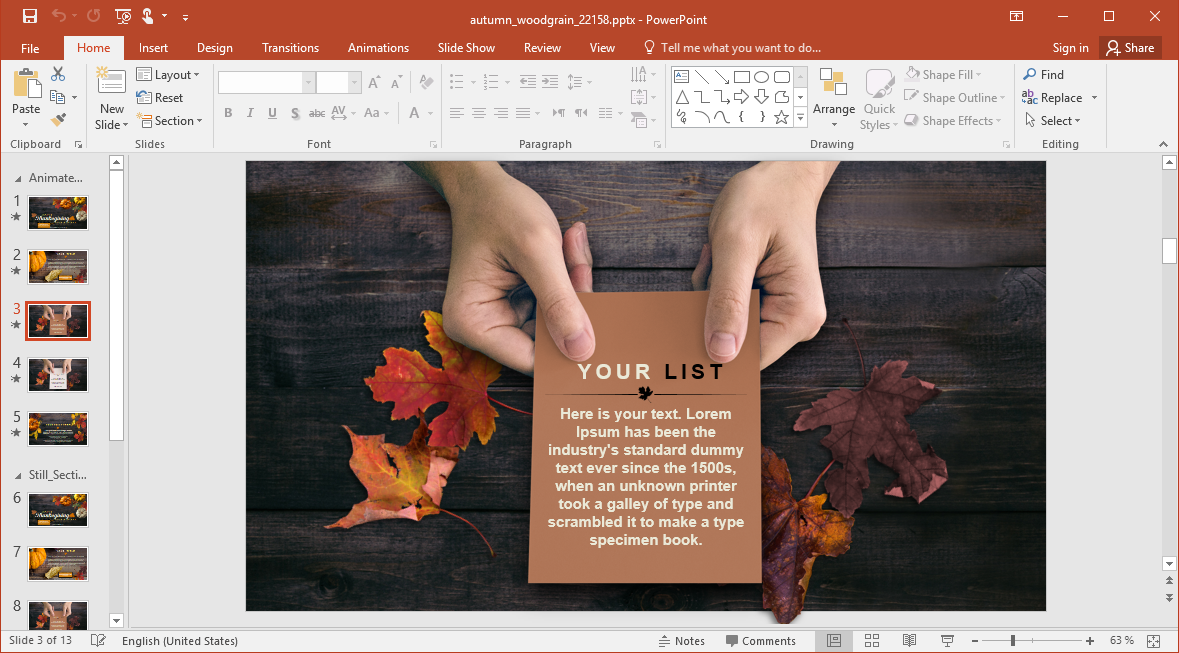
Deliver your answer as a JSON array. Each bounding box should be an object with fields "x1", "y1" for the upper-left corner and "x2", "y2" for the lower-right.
[{"x1": 246, "y1": 388, "x2": 1046, "y2": 514}]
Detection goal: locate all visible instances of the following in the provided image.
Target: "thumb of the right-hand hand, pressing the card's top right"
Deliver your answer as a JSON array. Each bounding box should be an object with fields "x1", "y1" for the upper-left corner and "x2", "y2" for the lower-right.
[{"x1": 702, "y1": 237, "x2": 762, "y2": 363}]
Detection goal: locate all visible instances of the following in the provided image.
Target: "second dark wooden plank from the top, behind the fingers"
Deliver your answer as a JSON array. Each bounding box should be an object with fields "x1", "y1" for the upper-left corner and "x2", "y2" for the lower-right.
[{"x1": 246, "y1": 268, "x2": 1046, "y2": 388}]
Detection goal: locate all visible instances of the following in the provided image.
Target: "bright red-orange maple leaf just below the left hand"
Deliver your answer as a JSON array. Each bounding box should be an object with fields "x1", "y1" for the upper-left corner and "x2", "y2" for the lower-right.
[{"x1": 364, "y1": 311, "x2": 500, "y2": 449}]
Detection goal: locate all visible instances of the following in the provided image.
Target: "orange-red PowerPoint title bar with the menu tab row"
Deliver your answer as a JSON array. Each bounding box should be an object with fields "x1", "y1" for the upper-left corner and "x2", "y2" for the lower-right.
[{"x1": 0, "y1": 0, "x2": 1179, "y2": 60}]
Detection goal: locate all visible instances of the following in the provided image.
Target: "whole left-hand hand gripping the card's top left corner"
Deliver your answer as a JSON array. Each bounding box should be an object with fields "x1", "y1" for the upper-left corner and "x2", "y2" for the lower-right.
[{"x1": 409, "y1": 161, "x2": 595, "y2": 375}]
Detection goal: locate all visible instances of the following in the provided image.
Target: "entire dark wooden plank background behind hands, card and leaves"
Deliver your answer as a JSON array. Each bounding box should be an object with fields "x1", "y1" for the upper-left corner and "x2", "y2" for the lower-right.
[{"x1": 246, "y1": 161, "x2": 1047, "y2": 608}]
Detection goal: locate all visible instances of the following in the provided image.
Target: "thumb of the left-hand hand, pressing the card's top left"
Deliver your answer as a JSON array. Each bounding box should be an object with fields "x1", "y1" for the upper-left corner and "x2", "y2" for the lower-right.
[{"x1": 516, "y1": 239, "x2": 594, "y2": 361}]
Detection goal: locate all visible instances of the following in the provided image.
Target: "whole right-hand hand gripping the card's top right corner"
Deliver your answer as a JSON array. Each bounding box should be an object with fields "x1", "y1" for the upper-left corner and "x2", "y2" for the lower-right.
[{"x1": 692, "y1": 161, "x2": 838, "y2": 369}]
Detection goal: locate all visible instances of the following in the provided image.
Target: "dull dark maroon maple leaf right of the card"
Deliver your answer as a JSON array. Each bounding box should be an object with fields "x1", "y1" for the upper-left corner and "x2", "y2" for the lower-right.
[{"x1": 795, "y1": 361, "x2": 949, "y2": 516}]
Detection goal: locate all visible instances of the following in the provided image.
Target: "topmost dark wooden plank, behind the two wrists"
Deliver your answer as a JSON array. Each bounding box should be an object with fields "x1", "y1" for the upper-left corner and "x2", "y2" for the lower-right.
[{"x1": 246, "y1": 161, "x2": 1046, "y2": 270}]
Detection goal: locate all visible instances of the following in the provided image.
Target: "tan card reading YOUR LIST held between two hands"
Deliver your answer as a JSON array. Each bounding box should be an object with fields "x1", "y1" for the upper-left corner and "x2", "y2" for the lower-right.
[{"x1": 528, "y1": 290, "x2": 762, "y2": 583}]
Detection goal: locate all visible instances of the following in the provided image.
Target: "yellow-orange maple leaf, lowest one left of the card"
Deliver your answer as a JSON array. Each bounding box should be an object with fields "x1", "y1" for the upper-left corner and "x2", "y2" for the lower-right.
[{"x1": 324, "y1": 411, "x2": 459, "y2": 528}]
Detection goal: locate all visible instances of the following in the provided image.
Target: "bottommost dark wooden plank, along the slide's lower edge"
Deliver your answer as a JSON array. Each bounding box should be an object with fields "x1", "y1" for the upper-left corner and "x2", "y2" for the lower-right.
[{"x1": 245, "y1": 510, "x2": 1046, "y2": 608}]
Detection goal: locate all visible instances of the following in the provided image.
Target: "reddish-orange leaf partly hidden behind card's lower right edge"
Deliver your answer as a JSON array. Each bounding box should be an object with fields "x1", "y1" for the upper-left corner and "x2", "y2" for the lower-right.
[{"x1": 762, "y1": 447, "x2": 856, "y2": 624}]
